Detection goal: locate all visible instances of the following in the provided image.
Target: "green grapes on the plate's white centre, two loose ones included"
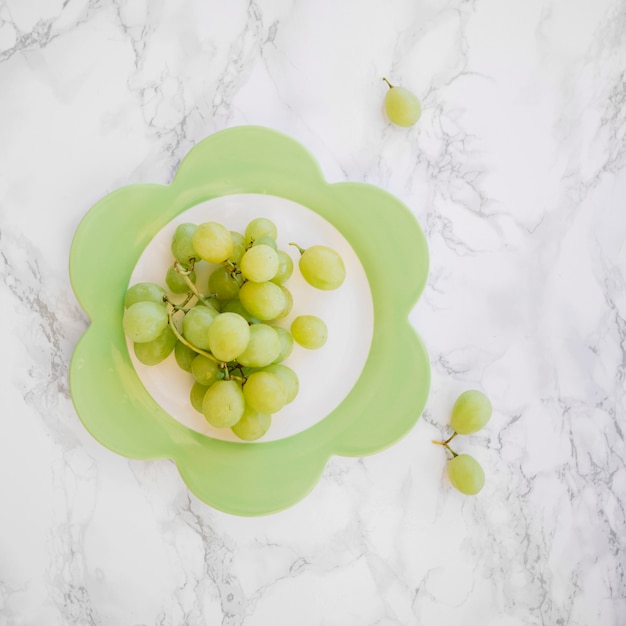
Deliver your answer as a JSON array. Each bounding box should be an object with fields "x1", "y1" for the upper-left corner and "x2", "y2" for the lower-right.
[{"x1": 123, "y1": 217, "x2": 346, "y2": 441}]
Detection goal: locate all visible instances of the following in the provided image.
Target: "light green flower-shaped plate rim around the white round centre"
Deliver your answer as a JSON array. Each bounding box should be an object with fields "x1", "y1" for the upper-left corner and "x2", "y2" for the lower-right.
[{"x1": 70, "y1": 126, "x2": 430, "y2": 515}]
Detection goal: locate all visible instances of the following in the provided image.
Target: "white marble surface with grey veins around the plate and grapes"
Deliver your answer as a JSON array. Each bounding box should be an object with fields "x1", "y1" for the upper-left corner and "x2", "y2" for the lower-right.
[{"x1": 0, "y1": 0, "x2": 626, "y2": 626}]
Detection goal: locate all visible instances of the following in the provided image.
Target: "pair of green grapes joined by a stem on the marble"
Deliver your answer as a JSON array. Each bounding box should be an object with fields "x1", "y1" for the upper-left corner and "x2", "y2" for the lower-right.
[{"x1": 433, "y1": 389, "x2": 493, "y2": 495}]
